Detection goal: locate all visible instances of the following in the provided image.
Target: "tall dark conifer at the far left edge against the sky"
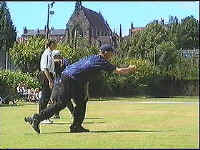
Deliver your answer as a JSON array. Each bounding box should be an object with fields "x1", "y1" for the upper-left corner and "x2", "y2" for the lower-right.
[{"x1": 0, "y1": 1, "x2": 17, "y2": 51}]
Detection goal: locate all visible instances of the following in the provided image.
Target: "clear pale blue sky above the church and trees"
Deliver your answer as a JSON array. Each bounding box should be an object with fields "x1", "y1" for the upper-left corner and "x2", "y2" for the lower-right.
[{"x1": 7, "y1": 1, "x2": 199, "y2": 37}]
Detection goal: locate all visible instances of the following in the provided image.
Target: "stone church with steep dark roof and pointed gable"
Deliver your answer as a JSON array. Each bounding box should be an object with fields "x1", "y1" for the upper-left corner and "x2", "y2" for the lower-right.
[{"x1": 66, "y1": 1, "x2": 113, "y2": 45}]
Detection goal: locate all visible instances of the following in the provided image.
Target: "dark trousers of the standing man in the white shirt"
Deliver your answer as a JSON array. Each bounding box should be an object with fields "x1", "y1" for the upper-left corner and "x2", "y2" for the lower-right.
[{"x1": 39, "y1": 71, "x2": 53, "y2": 113}]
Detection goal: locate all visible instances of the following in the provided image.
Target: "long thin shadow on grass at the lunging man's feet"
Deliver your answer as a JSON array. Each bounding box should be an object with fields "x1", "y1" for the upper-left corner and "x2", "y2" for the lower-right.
[{"x1": 40, "y1": 130, "x2": 173, "y2": 134}]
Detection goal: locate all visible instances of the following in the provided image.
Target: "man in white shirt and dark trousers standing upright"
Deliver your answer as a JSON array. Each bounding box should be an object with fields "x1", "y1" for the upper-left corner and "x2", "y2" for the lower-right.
[{"x1": 39, "y1": 40, "x2": 57, "y2": 123}]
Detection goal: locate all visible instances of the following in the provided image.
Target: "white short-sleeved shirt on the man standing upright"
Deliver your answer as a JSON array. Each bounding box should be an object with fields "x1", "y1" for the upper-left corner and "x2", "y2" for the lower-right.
[{"x1": 40, "y1": 49, "x2": 54, "y2": 73}]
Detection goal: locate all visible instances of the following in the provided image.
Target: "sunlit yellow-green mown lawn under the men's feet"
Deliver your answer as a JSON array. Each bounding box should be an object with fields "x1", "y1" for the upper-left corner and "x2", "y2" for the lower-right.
[{"x1": 0, "y1": 97, "x2": 199, "y2": 149}]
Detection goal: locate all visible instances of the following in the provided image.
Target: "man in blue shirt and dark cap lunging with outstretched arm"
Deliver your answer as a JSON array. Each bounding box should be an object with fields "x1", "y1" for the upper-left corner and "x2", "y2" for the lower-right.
[{"x1": 24, "y1": 45, "x2": 136, "y2": 133}]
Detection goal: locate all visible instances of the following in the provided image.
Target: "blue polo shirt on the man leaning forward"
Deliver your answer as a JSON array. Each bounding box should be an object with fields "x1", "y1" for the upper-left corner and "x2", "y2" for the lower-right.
[{"x1": 62, "y1": 55, "x2": 116, "y2": 81}]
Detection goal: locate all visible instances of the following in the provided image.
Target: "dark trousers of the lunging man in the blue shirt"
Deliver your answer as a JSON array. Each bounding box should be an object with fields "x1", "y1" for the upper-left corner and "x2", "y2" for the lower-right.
[{"x1": 38, "y1": 76, "x2": 88, "y2": 127}]
